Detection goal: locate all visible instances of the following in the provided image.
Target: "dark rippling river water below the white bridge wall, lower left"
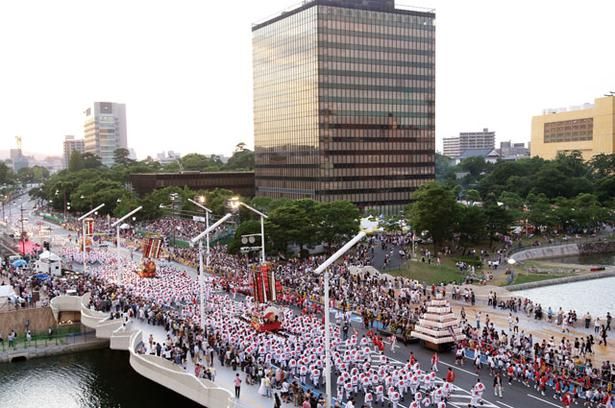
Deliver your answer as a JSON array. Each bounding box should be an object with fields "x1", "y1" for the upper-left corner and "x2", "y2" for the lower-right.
[{"x1": 0, "y1": 350, "x2": 200, "y2": 408}]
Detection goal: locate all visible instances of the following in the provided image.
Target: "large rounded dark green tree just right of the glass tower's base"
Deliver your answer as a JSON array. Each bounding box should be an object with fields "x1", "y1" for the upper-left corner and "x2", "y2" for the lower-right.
[{"x1": 406, "y1": 183, "x2": 457, "y2": 249}]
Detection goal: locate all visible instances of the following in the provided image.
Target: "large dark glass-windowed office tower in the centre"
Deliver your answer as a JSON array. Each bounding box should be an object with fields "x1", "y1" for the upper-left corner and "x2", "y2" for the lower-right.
[{"x1": 252, "y1": 0, "x2": 435, "y2": 210}]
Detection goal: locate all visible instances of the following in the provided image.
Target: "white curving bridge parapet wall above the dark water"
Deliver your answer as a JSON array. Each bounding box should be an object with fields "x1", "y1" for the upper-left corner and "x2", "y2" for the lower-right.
[{"x1": 50, "y1": 293, "x2": 236, "y2": 408}]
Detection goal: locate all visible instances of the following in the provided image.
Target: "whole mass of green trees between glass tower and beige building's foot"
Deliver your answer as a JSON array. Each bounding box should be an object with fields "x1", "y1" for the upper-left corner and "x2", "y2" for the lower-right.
[{"x1": 406, "y1": 152, "x2": 615, "y2": 249}]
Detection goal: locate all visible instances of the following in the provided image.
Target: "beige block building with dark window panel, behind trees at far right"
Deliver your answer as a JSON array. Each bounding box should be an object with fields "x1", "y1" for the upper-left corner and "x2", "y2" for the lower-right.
[{"x1": 531, "y1": 96, "x2": 615, "y2": 160}]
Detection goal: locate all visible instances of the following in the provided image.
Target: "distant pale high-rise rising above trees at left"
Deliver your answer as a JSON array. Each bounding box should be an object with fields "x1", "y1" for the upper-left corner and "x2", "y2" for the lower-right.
[{"x1": 83, "y1": 102, "x2": 128, "y2": 166}]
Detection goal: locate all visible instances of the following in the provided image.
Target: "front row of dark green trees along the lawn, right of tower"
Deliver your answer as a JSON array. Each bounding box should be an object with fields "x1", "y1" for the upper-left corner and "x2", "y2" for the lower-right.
[{"x1": 406, "y1": 182, "x2": 615, "y2": 247}]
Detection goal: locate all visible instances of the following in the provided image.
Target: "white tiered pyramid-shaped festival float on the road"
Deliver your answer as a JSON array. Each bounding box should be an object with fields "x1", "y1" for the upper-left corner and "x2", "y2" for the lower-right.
[{"x1": 411, "y1": 292, "x2": 465, "y2": 351}]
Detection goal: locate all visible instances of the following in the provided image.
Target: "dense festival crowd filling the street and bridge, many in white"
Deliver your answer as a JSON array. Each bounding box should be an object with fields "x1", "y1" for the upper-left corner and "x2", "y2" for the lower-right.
[{"x1": 2, "y1": 214, "x2": 613, "y2": 408}]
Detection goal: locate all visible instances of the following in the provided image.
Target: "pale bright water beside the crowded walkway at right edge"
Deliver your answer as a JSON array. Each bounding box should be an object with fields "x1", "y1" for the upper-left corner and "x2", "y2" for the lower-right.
[{"x1": 513, "y1": 277, "x2": 615, "y2": 316}]
